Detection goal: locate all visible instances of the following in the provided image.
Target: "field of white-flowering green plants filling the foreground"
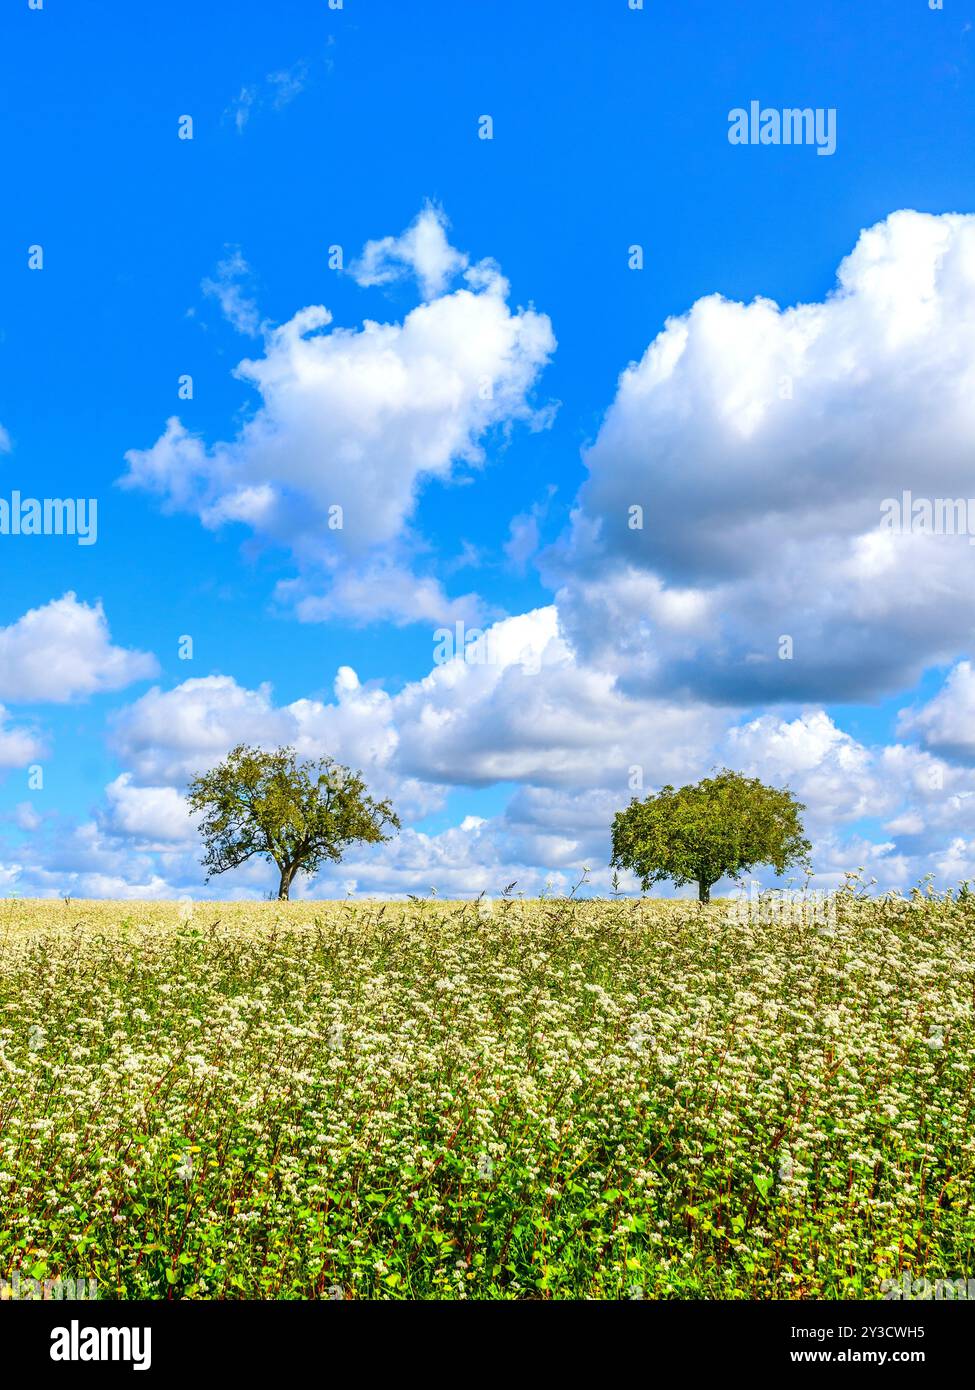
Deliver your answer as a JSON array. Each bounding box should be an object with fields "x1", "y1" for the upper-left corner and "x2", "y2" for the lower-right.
[{"x1": 0, "y1": 894, "x2": 975, "y2": 1298}]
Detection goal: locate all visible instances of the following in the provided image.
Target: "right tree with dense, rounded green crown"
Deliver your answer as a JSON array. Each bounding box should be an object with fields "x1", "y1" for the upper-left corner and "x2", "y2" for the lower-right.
[{"x1": 611, "y1": 769, "x2": 809, "y2": 902}]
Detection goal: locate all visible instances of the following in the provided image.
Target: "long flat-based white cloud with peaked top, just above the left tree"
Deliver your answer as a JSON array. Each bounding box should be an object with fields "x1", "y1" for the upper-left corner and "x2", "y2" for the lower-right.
[{"x1": 110, "y1": 607, "x2": 723, "y2": 867}]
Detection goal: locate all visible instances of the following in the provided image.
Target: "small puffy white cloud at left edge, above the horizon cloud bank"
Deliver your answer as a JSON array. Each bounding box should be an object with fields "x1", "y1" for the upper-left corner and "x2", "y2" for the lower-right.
[{"x1": 0, "y1": 594, "x2": 159, "y2": 703}]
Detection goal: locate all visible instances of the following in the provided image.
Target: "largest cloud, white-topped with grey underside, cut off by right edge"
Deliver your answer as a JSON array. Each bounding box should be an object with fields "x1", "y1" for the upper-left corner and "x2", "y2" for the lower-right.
[{"x1": 548, "y1": 211, "x2": 975, "y2": 703}]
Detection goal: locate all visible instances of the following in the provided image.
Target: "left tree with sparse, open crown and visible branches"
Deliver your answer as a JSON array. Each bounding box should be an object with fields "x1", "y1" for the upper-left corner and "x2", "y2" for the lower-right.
[{"x1": 186, "y1": 744, "x2": 399, "y2": 898}]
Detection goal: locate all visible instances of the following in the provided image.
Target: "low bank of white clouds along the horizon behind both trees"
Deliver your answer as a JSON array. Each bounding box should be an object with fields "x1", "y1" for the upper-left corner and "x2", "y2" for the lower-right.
[{"x1": 11, "y1": 607, "x2": 975, "y2": 897}]
